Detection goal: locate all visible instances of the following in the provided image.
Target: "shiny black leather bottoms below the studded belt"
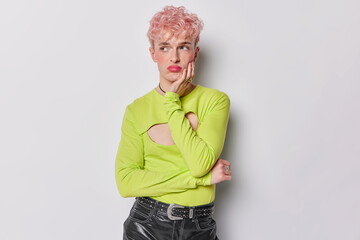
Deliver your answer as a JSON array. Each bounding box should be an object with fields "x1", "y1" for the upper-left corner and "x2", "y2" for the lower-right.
[{"x1": 123, "y1": 200, "x2": 218, "y2": 240}]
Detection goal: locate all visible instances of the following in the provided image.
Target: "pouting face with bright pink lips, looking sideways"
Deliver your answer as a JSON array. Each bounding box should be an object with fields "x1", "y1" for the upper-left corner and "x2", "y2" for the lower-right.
[{"x1": 149, "y1": 32, "x2": 200, "y2": 82}]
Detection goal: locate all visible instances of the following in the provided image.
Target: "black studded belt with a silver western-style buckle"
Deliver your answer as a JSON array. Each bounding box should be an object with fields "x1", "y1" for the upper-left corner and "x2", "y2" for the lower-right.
[{"x1": 136, "y1": 197, "x2": 214, "y2": 220}]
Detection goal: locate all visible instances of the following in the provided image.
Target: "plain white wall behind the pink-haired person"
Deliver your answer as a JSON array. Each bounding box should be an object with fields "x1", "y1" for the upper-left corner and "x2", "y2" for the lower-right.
[{"x1": 0, "y1": 0, "x2": 360, "y2": 240}]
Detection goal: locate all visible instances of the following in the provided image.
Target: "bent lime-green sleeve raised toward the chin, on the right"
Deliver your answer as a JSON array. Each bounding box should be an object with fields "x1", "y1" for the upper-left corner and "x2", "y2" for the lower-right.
[{"x1": 164, "y1": 92, "x2": 230, "y2": 177}]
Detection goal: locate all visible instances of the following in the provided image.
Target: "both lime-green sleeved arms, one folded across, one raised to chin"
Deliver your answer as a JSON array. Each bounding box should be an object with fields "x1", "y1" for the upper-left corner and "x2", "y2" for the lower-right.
[{"x1": 115, "y1": 92, "x2": 230, "y2": 197}]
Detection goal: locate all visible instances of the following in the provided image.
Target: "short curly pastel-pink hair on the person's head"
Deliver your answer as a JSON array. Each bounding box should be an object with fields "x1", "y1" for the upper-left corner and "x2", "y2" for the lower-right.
[{"x1": 147, "y1": 6, "x2": 204, "y2": 48}]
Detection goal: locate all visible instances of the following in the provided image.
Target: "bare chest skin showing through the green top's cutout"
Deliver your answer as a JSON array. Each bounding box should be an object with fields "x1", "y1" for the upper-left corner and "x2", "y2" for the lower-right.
[{"x1": 147, "y1": 112, "x2": 199, "y2": 145}]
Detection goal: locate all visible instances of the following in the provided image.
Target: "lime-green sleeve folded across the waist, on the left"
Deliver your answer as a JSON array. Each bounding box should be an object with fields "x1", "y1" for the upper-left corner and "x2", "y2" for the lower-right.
[{"x1": 115, "y1": 106, "x2": 211, "y2": 197}]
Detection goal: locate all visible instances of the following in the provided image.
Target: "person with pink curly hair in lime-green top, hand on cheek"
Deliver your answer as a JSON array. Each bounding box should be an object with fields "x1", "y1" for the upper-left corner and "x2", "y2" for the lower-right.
[{"x1": 115, "y1": 6, "x2": 231, "y2": 240}]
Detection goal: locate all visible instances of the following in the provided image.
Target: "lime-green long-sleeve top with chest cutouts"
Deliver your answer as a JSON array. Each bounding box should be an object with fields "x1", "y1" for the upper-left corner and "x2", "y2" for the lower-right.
[{"x1": 115, "y1": 85, "x2": 230, "y2": 206}]
